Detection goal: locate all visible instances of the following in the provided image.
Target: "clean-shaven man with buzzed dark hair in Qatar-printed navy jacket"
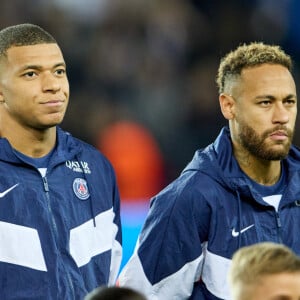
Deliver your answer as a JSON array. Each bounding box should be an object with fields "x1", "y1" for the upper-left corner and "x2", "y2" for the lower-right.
[{"x1": 0, "y1": 24, "x2": 122, "y2": 300}]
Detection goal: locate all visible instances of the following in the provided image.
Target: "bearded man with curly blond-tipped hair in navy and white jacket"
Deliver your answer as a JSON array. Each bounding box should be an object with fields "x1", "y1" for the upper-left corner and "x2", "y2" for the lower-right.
[{"x1": 119, "y1": 42, "x2": 300, "y2": 300}]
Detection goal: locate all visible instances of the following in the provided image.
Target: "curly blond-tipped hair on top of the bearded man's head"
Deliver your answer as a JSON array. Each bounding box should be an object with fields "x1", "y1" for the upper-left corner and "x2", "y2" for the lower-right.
[{"x1": 216, "y1": 42, "x2": 292, "y2": 93}]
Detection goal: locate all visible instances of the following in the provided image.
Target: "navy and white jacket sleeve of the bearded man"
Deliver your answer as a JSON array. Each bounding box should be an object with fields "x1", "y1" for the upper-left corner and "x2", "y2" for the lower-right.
[{"x1": 119, "y1": 175, "x2": 210, "y2": 300}]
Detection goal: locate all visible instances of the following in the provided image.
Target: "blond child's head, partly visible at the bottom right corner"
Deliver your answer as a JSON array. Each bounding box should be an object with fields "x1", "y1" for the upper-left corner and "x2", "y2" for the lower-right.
[{"x1": 229, "y1": 242, "x2": 300, "y2": 300}]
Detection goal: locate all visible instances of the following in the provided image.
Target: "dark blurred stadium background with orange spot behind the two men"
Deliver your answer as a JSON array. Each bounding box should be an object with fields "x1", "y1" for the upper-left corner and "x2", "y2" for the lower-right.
[{"x1": 0, "y1": 0, "x2": 300, "y2": 268}]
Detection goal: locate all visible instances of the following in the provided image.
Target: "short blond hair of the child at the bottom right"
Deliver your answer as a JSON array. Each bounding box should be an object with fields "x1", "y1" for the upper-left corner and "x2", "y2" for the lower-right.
[{"x1": 229, "y1": 242, "x2": 300, "y2": 300}]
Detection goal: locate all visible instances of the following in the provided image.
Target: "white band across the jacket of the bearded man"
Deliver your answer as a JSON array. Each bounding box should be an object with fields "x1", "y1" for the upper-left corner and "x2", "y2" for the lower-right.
[{"x1": 119, "y1": 242, "x2": 231, "y2": 300}]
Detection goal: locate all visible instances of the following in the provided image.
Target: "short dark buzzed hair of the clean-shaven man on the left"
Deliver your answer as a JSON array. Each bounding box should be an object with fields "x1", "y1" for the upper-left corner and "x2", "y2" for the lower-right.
[{"x1": 0, "y1": 23, "x2": 57, "y2": 57}]
